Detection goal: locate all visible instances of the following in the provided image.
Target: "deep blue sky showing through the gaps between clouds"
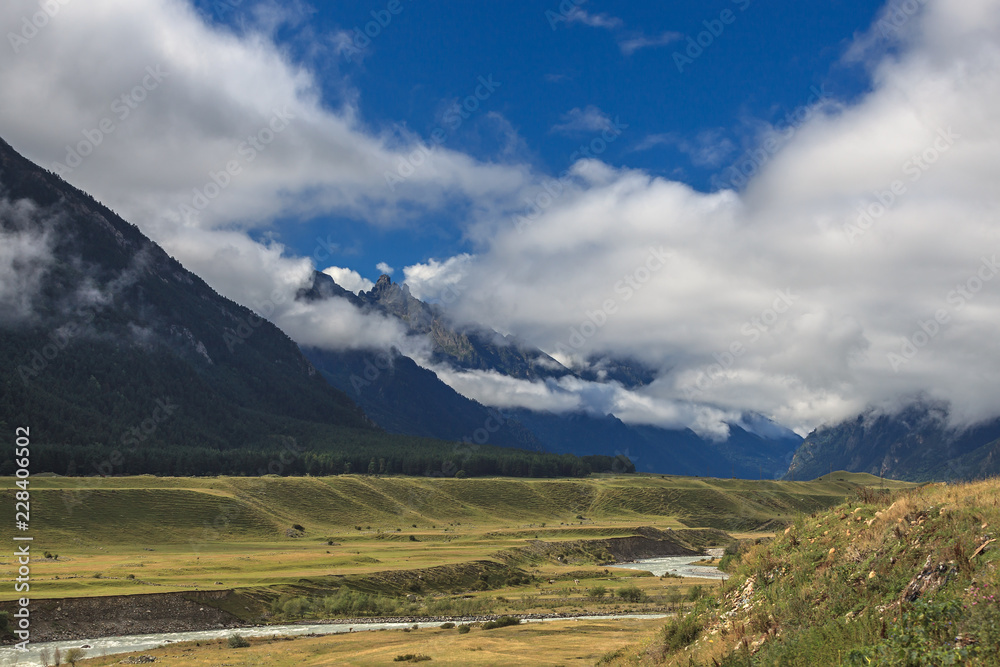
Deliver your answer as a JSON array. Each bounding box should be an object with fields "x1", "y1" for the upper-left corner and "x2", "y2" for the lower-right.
[{"x1": 198, "y1": 0, "x2": 882, "y2": 279}]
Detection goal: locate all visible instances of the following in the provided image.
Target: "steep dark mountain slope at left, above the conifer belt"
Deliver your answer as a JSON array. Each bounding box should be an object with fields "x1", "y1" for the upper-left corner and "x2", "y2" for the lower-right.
[{"x1": 0, "y1": 141, "x2": 373, "y2": 464}]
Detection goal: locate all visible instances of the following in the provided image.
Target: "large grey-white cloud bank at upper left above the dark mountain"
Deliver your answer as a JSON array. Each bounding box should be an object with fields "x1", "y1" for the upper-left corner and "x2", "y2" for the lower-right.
[{"x1": 0, "y1": 0, "x2": 527, "y2": 238}]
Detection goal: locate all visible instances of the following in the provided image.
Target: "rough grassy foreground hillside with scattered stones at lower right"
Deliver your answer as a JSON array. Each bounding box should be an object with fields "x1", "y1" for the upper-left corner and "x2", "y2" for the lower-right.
[{"x1": 603, "y1": 479, "x2": 1000, "y2": 667}]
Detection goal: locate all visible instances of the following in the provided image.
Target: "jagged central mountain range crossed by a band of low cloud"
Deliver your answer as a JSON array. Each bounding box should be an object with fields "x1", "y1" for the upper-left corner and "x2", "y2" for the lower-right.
[{"x1": 299, "y1": 272, "x2": 802, "y2": 479}]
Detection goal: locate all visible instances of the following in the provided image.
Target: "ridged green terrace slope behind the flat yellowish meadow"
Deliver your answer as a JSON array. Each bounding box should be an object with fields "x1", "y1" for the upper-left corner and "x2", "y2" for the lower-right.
[{"x1": 0, "y1": 475, "x2": 908, "y2": 547}]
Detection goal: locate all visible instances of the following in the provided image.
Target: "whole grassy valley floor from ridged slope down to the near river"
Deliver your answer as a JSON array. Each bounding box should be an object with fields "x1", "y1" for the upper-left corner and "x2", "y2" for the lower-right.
[{"x1": 0, "y1": 475, "x2": 910, "y2": 664}]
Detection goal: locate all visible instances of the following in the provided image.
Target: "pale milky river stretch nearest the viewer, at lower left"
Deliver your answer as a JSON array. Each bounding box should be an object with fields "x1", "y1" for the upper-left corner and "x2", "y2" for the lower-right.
[{"x1": 0, "y1": 614, "x2": 669, "y2": 667}]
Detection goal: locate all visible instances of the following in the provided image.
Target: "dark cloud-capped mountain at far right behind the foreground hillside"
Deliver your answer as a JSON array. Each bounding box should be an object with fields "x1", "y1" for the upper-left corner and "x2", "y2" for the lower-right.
[{"x1": 787, "y1": 401, "x2": 1000, "y2": 481}]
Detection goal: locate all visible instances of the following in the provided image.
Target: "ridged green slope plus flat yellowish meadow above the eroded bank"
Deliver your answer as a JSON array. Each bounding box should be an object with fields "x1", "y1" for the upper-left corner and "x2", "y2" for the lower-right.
[{"x1": 0, "y1": 475, "x2": 908, "y2": 599}]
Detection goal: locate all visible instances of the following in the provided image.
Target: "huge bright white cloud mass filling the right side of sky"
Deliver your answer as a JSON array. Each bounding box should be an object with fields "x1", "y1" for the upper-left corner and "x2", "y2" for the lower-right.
[{"x1": 422, "y1": 0, "x2": 1000, "y2": 432}]
